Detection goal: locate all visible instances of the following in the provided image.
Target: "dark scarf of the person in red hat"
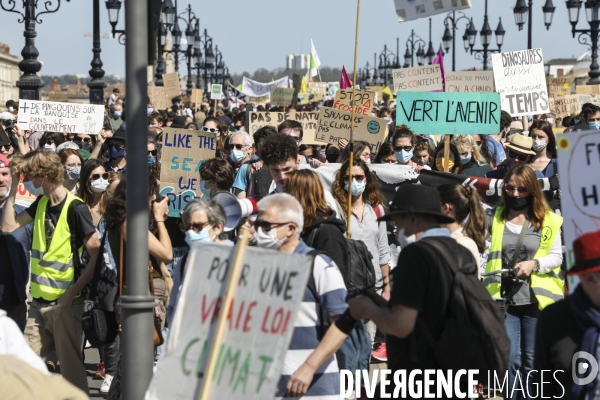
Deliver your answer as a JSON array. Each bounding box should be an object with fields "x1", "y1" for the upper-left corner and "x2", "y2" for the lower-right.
[{"x1": 570, "y1": 284, "x2": 600, "y2": 399}]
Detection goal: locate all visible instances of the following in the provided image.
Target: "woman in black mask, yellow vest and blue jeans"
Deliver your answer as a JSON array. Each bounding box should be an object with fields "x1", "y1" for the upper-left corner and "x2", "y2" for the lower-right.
[{"x1": 483, "y1": 164, "x2": 564, "y2": 399}]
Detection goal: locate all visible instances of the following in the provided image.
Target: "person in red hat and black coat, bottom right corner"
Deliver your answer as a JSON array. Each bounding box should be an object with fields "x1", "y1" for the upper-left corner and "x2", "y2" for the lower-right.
[{"x1": 534, "y1": 231, "x2": 600, "y2": 399}]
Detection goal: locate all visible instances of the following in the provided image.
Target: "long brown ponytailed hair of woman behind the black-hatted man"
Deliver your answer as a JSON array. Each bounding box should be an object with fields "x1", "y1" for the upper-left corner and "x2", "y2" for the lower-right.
[{"x1": 437, "y1": 183, "x2": 486, "y2": 253}]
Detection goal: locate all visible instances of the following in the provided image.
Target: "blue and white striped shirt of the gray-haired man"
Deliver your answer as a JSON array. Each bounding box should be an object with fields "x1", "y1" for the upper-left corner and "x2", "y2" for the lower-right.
[{"x1": 276, "y1": 241, "x2": 348, "y2": 400}]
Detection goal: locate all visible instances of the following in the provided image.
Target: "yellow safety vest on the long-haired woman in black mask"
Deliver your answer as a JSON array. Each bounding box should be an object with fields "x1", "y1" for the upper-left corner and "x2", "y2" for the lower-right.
[{"x1": 483, "y1": 207, "x2": 564, "y2": 310}]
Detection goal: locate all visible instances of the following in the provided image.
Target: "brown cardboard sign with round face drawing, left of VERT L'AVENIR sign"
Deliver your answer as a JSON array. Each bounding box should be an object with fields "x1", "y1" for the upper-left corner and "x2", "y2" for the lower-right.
[{"x1": 316, "y1": 107, "x2": 387, "y2": 153}]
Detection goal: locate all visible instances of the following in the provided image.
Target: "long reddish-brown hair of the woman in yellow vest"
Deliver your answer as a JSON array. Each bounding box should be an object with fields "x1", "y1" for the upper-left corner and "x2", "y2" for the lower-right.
[{"x1": 500, "y1": 164, "x2": 550, "y2": 231}]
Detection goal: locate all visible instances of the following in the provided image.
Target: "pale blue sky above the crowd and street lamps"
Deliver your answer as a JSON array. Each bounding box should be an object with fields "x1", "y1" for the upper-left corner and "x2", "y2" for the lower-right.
[{"x1": 0, "y1": 0, "x2": 589, "y2": 76}]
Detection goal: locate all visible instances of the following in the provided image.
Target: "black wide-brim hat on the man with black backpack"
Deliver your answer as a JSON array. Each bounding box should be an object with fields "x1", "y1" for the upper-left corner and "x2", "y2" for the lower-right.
[{"x1": 377, "y1": 184, "x2": 455, "y2": 224}]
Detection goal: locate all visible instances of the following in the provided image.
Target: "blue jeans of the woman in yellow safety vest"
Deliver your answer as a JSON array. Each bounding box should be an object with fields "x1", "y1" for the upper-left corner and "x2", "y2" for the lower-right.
[{"x1": 504, "y1": 304, "x2": 540, "y2": 400}]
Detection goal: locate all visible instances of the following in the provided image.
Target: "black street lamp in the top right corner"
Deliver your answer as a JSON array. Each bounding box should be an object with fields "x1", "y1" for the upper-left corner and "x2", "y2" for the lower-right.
[{"x1": 567, "y1": 0, "x2": 600, "y2": 85}]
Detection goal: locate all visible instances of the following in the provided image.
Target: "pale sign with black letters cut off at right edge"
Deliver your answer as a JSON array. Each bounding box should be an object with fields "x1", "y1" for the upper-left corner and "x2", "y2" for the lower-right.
[{"x1": 556, "y1": 130, "x2": 600, "y2": 291}]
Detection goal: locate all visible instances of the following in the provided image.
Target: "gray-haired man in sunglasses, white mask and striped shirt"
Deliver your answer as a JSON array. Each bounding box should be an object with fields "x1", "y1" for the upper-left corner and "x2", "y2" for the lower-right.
[{"x1": 254, "y1": 193, "x2": 347, "y2": 399}]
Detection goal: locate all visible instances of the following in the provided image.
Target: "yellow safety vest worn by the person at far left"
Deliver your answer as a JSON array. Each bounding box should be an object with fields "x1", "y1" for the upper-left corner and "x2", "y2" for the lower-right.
[{"x1": 31, "y1": 192, "x2": 83, "y2": 301}]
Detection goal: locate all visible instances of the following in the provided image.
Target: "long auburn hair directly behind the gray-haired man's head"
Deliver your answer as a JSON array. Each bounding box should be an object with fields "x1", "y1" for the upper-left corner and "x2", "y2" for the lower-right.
[{"x1": 285, "y1": 169, "x2": 331, "y2": 230}]
